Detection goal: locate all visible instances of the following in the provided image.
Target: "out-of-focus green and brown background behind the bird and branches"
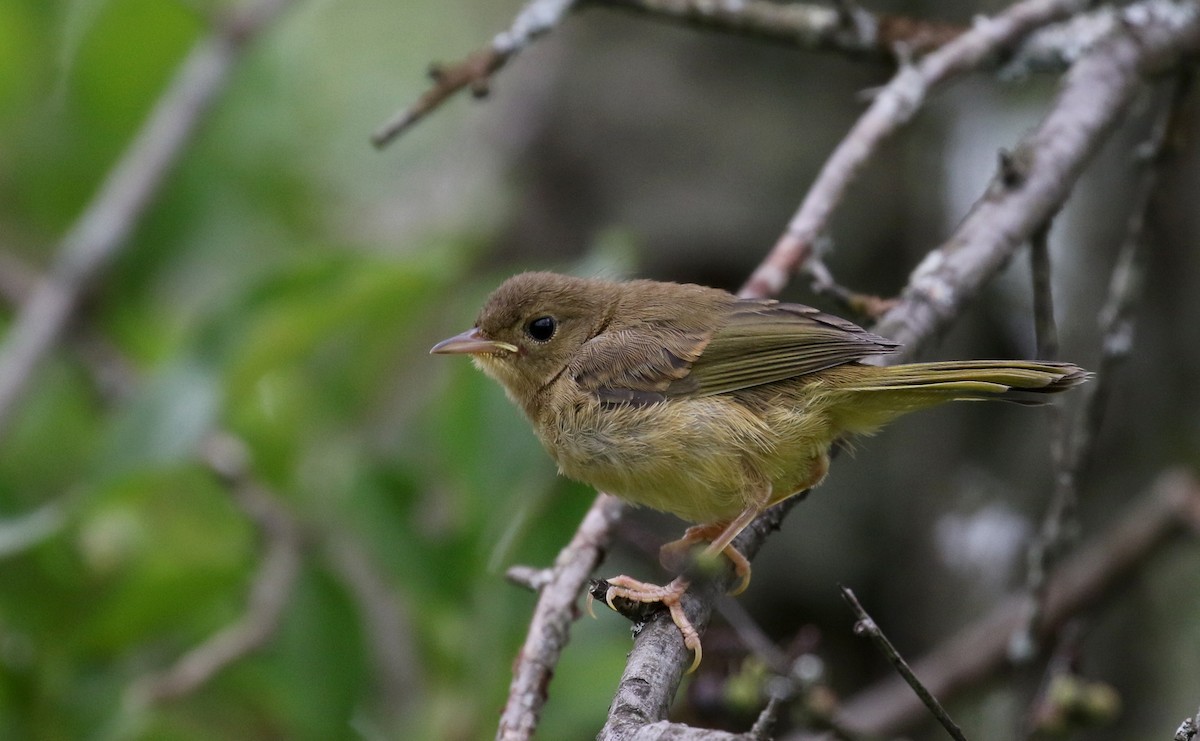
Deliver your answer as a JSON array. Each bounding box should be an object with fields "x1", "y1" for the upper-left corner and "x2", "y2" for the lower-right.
[{"x1": 0, "y1": 0, "x2": 1200, "y2": 740}]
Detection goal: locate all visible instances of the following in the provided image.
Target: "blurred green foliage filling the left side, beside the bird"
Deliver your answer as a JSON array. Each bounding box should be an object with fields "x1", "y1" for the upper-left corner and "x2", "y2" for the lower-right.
[{"x1": 0, "y1": 0, "x2": 625, "y2": 740}]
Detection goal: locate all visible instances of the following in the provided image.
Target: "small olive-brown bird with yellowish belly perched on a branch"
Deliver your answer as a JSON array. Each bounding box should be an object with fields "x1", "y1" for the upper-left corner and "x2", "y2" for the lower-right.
[{"x1": 430, "y1": 272, "x2": 1091, "y2": 670}]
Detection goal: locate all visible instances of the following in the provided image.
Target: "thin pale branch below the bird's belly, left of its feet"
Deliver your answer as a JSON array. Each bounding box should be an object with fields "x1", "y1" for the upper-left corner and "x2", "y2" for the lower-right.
[{"x1": 496, "y1": 494, "x2": 624, "y2": 741}]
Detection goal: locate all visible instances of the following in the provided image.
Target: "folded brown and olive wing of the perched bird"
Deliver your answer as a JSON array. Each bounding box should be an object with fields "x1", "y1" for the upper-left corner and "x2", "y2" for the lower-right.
[{"x1": 569, "y1": 300, "x2": 899, "y2": 405}]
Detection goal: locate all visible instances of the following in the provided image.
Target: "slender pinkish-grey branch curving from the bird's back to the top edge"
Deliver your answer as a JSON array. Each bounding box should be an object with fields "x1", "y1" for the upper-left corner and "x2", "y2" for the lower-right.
[{"x1": 742, "y1": 0, "x2": 1086, "y2": 297}]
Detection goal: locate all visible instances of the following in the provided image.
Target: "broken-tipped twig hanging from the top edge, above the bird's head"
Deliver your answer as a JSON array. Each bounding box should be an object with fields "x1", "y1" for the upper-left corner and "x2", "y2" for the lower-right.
[{"x1": 371, "y1": 0, "x2": 578, "y2": 149}]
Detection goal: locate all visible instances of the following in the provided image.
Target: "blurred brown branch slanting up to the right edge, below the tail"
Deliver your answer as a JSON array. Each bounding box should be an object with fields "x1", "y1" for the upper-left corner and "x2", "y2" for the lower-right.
[{"x1": 838, "y1": 471, "x2": 1200, "y2": 735}]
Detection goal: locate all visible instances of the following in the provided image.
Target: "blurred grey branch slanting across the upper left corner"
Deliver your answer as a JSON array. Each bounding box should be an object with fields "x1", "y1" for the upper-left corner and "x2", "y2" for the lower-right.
[{"x1": 0, "y1": 0, "x2": 286, "y2": 436}]
